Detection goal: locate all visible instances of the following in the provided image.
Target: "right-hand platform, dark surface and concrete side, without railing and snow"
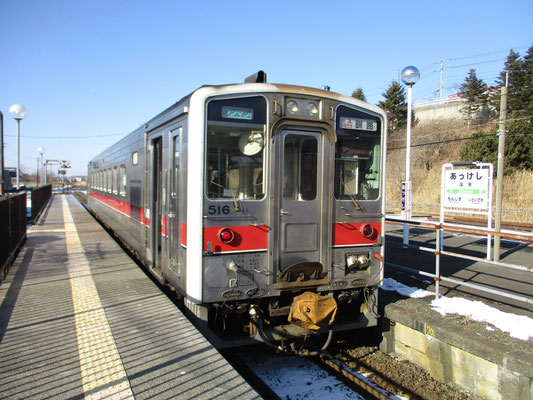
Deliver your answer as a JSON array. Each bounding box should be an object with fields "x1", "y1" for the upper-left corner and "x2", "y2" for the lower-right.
[{"x1": 379, "y1": 227, "x2": 533, "y2": 400}]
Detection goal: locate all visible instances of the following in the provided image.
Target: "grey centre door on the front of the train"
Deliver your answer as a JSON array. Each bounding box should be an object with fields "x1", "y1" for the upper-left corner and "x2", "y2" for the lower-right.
[{"x1": 278, "y1": 130, "x2": 329, "y2": 279}]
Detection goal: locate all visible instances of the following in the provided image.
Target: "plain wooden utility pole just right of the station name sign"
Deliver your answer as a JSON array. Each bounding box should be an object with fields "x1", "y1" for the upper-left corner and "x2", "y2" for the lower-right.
[{"x1": 494, "y1": 72, "x2": 509, "y2": 261}]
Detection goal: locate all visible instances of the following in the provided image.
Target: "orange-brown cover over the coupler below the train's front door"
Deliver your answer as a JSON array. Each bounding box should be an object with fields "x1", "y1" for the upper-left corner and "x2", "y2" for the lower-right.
[{"x1": 289, "y1": 292, "x2": 337, "y2": 330}]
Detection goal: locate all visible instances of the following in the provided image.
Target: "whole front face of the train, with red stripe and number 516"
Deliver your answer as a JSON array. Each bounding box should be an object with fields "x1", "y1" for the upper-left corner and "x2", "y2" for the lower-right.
[{"x1": 184, "y1": 84, "x2": 386, "y2": 338}]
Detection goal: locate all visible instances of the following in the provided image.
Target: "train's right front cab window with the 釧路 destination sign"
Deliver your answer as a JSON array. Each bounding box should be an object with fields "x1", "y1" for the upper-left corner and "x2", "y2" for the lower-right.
[{"x1": 335, "y1": 106, "x2": 381, "y2": 200}]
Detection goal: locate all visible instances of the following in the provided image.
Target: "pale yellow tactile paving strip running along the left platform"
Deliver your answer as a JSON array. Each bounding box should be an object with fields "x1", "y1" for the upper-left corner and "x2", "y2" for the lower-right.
[{"x1": 62, "y1": 196, "x2": 134, "y2": 400}]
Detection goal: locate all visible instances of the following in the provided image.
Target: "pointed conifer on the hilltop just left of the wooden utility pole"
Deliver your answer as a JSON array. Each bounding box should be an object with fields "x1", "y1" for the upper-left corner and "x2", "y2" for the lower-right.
[{"x1": 459, "y1": 69, "x2": 491, "y2": 126}]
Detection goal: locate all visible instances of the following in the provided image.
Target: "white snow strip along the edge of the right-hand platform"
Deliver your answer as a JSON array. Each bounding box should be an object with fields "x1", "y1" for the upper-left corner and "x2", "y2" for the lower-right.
[{"x1": 381, "y1": 278, "x2": 533, "y2": 340}]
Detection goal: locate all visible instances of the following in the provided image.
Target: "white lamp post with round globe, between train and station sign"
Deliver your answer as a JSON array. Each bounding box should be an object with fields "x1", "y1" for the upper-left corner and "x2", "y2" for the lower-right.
[{"x1": 401, "y1": 66, "x2": 420, "y2": 244}]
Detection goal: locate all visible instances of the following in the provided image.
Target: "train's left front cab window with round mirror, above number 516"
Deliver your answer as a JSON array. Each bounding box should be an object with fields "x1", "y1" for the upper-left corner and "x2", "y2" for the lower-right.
[{"x1": 206, "y1": 97, "x2": 267, "y2": 200}]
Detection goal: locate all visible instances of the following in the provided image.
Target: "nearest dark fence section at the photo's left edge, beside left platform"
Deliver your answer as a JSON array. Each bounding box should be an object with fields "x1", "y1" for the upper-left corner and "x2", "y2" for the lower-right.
[{"x1": 0, "y1": 193, "x2": 27, "y2": 283}]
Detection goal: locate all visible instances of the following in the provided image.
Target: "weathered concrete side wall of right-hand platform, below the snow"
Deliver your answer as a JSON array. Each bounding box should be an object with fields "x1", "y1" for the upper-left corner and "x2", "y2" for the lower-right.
[{"x1": 380, "y1": 304, "x2": 533, "y2": 400}]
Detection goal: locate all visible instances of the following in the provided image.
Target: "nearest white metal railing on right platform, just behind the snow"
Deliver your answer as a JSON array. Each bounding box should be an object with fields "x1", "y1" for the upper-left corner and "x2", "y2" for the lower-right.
[{"x1": 385, "y1": 217, "x2": 533, "y2": 304}]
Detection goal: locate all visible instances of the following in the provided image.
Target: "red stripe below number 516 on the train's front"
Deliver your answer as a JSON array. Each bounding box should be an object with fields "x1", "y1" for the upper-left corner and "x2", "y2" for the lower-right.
[{"x1": 204, "y1": 225, "x2": 268, "y2": 253}]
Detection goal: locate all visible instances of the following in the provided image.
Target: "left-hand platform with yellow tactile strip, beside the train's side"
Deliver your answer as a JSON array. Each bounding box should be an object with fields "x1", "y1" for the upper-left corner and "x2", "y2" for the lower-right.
[{"x1": 0, "y1": 195, "x2": 260, "y2": 399}]
